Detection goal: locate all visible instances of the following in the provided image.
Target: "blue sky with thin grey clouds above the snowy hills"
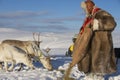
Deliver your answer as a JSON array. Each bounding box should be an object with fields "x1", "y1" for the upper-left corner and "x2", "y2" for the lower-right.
[{"x1": 0, "y1": 0, "x2": 120, "y2": 32}]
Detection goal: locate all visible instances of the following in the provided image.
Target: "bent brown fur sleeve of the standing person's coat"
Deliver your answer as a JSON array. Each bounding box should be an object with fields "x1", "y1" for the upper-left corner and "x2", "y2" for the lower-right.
[{"x1": 95, "y1": 10, "x2": 116, "y2": 31}]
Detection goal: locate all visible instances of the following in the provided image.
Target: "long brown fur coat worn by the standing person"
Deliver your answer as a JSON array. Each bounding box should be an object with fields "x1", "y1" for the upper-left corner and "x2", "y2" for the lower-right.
[{"x1": 72, "y1": 10, "x2": 116, "y2": 74}]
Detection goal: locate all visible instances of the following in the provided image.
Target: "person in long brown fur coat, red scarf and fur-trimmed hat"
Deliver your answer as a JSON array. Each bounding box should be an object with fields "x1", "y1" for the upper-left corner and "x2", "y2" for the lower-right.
[{"x1": 70, "y1": 0, "x2": 116, "y2": 75}]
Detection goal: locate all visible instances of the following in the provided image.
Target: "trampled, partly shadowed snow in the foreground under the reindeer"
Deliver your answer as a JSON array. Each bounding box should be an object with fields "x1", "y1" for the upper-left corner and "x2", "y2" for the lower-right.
[{"x1": 0, "y1": 56, "x2": 120, "y2": 80}]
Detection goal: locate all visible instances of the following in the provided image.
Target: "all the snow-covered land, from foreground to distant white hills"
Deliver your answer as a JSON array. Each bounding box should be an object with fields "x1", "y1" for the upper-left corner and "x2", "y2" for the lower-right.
[{"x1": 0, "y1": 28, "x2": 120, "y2": 80}]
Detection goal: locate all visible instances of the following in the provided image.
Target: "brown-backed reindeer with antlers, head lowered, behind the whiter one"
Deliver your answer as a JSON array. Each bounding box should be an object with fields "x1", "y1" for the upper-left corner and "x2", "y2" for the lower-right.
[{"x1": 2, "y1": 34, "x2": 52, "y2": 70}]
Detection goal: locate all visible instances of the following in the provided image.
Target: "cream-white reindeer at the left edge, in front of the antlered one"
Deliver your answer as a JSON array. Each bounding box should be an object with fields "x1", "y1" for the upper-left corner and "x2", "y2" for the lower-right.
[{"x1": 0, "y1": 43, "x2": 34, "y2": 71}]
